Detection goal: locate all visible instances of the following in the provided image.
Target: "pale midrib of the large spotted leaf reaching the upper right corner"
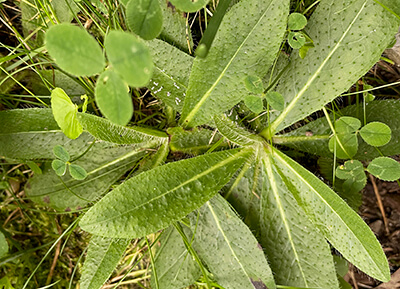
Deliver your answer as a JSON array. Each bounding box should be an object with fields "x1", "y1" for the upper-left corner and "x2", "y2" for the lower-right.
[{"x1": 271, "y1": 0, "x2": 367, "y2": 133}]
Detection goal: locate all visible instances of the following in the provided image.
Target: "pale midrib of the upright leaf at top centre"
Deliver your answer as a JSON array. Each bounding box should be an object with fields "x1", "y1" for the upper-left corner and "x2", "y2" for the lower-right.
[{"x1": 182, "y1": 0, "x2": 274, "y2": 126}]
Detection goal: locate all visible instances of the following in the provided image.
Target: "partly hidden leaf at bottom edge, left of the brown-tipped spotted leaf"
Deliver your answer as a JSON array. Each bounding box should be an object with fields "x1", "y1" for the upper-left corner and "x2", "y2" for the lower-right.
[{"x1": 151, "y1": 226, "x2": 201, "y2": 289}]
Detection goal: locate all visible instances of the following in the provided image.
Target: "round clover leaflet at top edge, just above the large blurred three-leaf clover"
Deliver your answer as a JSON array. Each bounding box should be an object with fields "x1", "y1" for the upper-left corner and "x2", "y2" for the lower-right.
[{"x1": 126, "y1": 0, "x2": 163, "y2": 40}]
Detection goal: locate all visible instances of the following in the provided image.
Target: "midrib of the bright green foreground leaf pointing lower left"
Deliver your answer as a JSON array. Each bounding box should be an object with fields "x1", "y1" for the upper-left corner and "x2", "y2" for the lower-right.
[{"x1": 85, "y1": 149, "x2": 249, "y2": 226}]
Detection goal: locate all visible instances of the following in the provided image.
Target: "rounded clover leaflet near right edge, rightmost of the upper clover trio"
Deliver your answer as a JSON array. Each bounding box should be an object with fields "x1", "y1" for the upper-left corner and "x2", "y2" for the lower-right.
[{"x1": 360, "y1": 122, "x2": 392, "y2": 147}]
